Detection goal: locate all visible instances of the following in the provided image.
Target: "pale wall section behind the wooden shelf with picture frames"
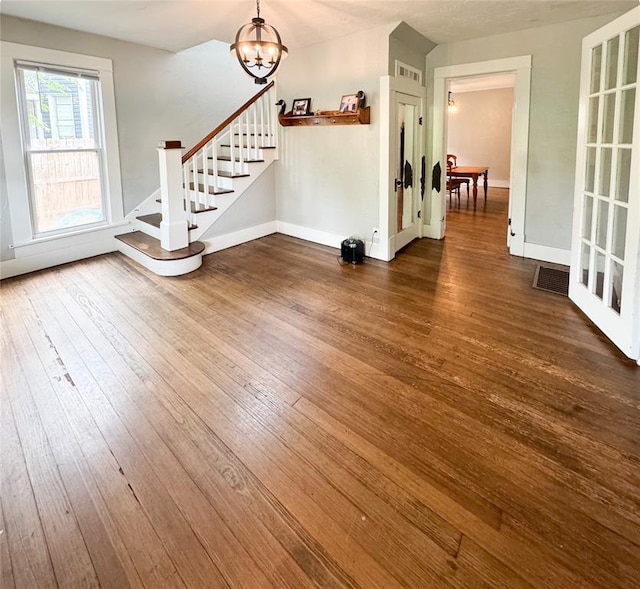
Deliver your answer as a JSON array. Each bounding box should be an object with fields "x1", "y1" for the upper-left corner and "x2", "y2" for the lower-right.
[{"x1": 276, "y1": 28, "x2": 389, "y2": 245}]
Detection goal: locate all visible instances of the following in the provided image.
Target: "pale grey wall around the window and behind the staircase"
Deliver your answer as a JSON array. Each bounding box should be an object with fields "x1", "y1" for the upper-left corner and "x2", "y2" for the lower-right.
[{"x1": 0, "y1": 15, "x2": 260, "y2": 260}]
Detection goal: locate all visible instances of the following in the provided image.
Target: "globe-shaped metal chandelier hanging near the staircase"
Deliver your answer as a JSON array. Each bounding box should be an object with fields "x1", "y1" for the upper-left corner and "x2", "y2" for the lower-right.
[{"x1": 230, "y1": 0, "x2": 289, "y2": 84}]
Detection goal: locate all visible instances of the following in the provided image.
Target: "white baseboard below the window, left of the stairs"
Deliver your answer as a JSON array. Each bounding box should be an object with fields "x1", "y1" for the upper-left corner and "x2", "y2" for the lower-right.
[{"x1": 0, "y1": 223, "x2": 128, "y2": 278}]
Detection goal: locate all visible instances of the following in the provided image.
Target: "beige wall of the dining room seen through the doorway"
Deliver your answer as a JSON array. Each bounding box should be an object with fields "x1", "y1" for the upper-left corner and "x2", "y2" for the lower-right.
[{"x1": 447, "y1": 88, "x2": 513, "y2": 188}]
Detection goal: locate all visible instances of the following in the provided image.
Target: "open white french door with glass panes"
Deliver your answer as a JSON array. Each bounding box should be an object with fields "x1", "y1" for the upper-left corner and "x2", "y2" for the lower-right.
[{"x1": 569, "y1": 7, "x2": 640, "y2": 360}]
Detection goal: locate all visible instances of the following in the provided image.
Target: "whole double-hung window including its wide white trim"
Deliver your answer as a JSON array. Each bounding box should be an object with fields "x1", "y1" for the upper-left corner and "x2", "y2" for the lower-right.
[{"x1": 0, "y1": 42, "x2": 123, "y2": 247}]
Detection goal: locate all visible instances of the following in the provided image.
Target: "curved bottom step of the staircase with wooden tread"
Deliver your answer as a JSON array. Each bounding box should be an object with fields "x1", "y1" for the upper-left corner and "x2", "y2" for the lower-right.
[{"x1": 116, "y1": 231, "x2": 205, "y2": 276}]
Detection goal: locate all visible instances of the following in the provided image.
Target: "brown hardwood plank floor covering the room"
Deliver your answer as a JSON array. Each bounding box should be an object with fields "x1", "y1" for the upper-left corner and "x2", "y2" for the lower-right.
[{"x1": 0, "y1": 190, "x2": 640, "y2": 589}]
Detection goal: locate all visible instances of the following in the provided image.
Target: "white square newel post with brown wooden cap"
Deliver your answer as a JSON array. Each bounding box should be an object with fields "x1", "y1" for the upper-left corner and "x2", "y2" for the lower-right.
[{"x1": 158, "y1": 141, "x2": 189, "y2": 251}]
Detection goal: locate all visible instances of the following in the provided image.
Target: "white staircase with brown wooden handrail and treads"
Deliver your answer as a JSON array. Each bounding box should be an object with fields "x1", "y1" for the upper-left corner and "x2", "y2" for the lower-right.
[{"x1": 116, "y1": 82, "x2": 277, "y2": 276}]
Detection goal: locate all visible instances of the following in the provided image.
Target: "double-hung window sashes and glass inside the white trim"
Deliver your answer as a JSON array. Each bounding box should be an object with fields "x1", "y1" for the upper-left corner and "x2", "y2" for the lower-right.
[{"x1": 16, "y1": 62, "x2": 106, "y2": 236}]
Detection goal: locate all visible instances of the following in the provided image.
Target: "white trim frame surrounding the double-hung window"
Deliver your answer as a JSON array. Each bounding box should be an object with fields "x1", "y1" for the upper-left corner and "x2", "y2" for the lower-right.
[{"x1": 0, "y1": 41, "x2": 124, "y2": 248}]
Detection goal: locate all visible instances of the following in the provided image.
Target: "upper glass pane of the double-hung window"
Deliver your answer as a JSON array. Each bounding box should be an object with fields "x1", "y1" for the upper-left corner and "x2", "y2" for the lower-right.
[{"x1": 20, "y1": 69, "x2": 98, "y2": 150}]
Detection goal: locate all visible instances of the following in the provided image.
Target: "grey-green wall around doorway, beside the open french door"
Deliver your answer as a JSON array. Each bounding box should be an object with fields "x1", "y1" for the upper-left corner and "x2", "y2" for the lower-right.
[{"x1": 427, "y1": 16, "x2": 614, "y2": 250}]
